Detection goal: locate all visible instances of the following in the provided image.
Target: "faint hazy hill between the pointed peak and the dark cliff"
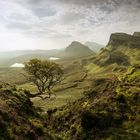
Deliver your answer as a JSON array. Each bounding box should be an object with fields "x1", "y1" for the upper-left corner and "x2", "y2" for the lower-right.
[{"x1": 85, "y1": 41, "x2": 105, "y2": 52}]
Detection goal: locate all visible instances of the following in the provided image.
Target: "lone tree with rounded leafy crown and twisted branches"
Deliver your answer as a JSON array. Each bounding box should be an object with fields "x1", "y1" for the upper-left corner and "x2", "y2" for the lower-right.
[{"x1": 24, "y1": 59, "x2": 63, "y2": 97}]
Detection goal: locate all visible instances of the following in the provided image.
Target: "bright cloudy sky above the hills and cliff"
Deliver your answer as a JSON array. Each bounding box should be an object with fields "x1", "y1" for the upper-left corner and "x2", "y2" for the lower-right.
[{"x1": 0, "y1": 0, "x2": 140, "y2": 51}]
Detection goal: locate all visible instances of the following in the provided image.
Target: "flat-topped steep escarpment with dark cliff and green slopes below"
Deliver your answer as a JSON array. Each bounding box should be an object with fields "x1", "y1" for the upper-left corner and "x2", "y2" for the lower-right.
[{"x1": 87, "y1": 32, "x2": 140, "y2": 66}]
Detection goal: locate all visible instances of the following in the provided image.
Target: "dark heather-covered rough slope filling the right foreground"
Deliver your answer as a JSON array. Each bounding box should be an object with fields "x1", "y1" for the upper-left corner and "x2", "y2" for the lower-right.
[{"x1": 45, "y1": 67, "x2": 140, "y2": 140}]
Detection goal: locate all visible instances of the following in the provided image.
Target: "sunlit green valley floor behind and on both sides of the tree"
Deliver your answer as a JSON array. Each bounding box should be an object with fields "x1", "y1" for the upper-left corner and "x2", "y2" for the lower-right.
[{"x1": 0, "y1": 56, "x2": 129, "y2": 111}]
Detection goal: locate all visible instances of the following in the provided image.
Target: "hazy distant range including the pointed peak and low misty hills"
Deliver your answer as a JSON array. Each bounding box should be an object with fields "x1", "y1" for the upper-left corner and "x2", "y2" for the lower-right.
[{"x1": 0, "y1": 41, "x2": 95, "y2": 67}]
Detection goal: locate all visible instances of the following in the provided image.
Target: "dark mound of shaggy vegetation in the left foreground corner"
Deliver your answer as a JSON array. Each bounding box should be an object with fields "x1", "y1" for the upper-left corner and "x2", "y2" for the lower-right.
[{"x1": 0, "y1": 84, "x2": 37, "y2": 140}]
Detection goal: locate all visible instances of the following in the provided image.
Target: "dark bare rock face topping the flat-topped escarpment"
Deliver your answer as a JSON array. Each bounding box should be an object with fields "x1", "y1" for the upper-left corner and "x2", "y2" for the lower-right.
[{"x1": 107, "y1": 32, "x2": 140, "y2": 48}]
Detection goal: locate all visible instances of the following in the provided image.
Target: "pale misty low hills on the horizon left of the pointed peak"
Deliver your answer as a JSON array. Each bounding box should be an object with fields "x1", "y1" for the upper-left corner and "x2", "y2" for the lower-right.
[{"x1": 0, "y1": 50, "x2": 61, "y2": 67}]
